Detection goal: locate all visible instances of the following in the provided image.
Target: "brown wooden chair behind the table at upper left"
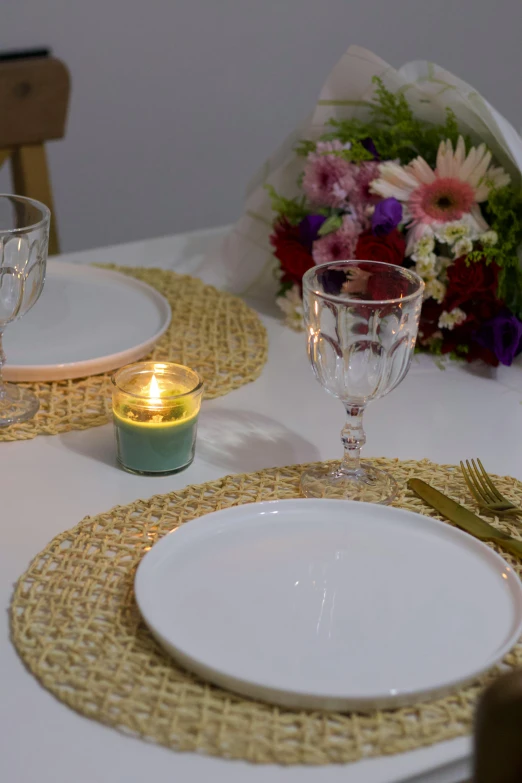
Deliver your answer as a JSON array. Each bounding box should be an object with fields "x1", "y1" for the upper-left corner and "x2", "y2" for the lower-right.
[{"x1": 0, "y1": 56, "x2": 70, "y2": 254}]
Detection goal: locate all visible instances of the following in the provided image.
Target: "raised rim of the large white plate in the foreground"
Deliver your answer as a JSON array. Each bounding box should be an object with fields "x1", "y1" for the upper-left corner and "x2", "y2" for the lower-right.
[{"x1": 134, "y1": 498, "x2": 522, "y2": 712}]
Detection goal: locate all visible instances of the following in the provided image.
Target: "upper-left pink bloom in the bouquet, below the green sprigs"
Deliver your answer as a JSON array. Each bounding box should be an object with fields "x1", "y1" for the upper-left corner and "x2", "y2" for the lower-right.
[{"x1": 303, "y1": 149, "x2": 355, "y2": 208}]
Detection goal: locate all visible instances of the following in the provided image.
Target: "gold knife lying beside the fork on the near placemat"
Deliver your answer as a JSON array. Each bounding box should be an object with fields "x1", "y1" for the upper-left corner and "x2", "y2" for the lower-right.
[{"x1": 408, "y1": 479, "x2": 522, "y2": 557}]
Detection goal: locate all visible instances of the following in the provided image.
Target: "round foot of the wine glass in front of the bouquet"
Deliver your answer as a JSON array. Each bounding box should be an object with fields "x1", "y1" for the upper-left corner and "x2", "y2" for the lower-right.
[{"x1": 301, "y1": 461, "x2": 399, "y2": 505}]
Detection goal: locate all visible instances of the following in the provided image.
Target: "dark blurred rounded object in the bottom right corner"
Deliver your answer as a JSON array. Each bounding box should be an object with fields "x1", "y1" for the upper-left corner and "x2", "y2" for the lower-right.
[{"x1": 473, "y1": 669, "x2": 522, "y2": 783}]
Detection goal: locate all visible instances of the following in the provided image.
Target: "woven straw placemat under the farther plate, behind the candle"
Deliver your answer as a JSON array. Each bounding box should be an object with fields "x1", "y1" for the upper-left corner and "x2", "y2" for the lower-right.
[{"x1": 0, "y1": 265, "x2": 268, "y2": 441}]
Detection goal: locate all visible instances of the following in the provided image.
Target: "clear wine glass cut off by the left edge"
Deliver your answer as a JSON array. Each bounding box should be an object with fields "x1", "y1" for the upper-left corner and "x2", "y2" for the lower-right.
[{"x1": 0, "y1": 199, "x2": 51, "y2": 427}]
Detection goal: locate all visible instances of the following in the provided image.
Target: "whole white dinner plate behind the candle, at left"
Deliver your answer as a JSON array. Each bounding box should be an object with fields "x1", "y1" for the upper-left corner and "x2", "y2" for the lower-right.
[{"x1": 4, "y1": 261, "x2": 171, "y2": 381}]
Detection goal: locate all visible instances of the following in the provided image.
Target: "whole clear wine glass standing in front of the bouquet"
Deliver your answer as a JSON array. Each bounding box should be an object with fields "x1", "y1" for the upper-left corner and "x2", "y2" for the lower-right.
[{"x1": 301, "y1": 261, "x2": 424, "y2": 503}]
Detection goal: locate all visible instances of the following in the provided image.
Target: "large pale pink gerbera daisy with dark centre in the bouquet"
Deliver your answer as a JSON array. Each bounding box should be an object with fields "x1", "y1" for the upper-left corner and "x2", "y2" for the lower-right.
[{"x1": 370, "y1": 136, "x2": 510, "y2": 254}]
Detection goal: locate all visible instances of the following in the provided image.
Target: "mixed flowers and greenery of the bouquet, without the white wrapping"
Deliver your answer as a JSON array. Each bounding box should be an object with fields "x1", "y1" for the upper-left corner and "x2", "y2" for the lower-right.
[{"x1": 267, "y1": 86, "x2": 522, "y2": 365}]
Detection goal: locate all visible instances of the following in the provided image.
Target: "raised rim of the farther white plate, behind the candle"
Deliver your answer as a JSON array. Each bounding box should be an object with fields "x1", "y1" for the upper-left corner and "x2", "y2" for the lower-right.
[{"x1": 3, "y1": 259, "x2": 172, "y2": 383}]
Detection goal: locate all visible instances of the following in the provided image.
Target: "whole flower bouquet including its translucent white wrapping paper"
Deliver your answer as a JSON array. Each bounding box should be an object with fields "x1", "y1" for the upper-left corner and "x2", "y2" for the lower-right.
[{"x1": 202, "y1": 47, "x2": 522, "y2": 365}]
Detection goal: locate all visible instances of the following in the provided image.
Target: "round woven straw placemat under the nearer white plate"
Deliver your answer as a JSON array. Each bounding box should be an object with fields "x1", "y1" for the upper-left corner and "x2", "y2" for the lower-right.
[{"x1": 11, "y1": 459, "x2": 522, "y2": 764}]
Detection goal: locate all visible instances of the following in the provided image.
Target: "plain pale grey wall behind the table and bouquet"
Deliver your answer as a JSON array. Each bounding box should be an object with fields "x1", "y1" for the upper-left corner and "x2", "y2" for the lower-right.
[{"x1": 4, "y1": 0, "x2": 522, "y2": 250}]
